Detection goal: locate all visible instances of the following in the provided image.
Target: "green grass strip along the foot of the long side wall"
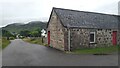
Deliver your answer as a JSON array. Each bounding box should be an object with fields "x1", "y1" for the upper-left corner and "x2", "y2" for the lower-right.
[{"x1": 72, "y1": 46, "x2": 118, "y2": 54}]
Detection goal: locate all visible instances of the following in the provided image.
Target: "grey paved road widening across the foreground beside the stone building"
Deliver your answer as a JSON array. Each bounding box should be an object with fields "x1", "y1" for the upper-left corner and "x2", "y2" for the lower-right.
[{"x1": 2, "y1": 39, "x2": 118, "y2": 66}]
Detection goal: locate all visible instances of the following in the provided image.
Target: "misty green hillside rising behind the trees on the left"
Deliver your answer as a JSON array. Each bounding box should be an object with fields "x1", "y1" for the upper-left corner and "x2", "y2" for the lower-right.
[{"x1": 2, "y1": 21, "x2": 47, "y2": 33}]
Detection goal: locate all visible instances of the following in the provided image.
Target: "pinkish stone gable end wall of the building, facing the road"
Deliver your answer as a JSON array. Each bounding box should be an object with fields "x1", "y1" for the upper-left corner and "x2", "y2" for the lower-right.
[{"x1": 47, "y1": 11, "x2": 64, "y2": 51}]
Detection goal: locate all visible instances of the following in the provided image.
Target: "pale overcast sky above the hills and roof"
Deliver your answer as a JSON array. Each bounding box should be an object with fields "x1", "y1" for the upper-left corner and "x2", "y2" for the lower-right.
[{"x1": 0, "y1": 0, "x2": 120, "y2": 27}]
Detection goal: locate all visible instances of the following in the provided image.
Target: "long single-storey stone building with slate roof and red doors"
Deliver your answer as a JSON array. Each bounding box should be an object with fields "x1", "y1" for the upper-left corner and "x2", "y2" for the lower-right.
[{"x1": 47, "y1": 8, "x2": 120, "y2": 51}]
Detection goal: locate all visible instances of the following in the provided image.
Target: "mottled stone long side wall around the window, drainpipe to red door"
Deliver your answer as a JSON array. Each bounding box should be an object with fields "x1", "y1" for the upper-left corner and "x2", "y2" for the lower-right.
[{"x1": 70, "y1": 29, "x2": 117, "y2": 50}]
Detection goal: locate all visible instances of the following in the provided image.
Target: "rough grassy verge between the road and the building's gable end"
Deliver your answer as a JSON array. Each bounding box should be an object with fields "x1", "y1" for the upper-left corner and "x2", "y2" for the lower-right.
[{"x1": 23, "y1": 38, "x2": 47, "y2": 46}]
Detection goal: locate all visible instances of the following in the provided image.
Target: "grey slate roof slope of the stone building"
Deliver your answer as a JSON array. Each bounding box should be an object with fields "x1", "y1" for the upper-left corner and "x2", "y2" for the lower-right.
[{"x1": 53, "y1": 7, "x2": 120, "y2": 29}]
